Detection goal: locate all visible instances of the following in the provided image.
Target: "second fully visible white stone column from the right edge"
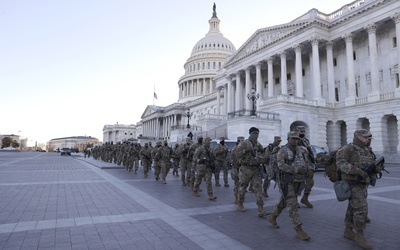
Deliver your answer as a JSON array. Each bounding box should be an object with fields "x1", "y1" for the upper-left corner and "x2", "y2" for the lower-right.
[{"x1": 342, "y1": 33, "x2": 356, "y2": 106}]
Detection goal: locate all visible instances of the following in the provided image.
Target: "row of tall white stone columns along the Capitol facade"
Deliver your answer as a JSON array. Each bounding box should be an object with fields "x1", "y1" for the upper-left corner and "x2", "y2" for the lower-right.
[{"x1": 219, "y1": 16, "x2": 400, "y2": 114}]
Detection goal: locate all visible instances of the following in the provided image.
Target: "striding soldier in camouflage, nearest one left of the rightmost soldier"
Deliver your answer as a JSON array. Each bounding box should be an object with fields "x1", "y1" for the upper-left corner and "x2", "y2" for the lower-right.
[{"x1": 268, "y1": 131, "x2": 310, "y2": 240}]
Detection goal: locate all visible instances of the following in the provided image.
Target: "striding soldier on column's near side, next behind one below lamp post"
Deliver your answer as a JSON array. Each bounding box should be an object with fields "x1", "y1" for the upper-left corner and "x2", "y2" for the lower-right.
[{"x1": 192, "y1": 137, "x2": 217, "y2": 200}]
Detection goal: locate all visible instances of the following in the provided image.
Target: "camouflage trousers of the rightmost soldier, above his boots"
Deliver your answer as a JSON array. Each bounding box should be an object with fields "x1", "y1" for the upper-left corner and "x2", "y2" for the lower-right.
[{"x1": 344, "y1": 184, "x2": 368, "y2": 230}]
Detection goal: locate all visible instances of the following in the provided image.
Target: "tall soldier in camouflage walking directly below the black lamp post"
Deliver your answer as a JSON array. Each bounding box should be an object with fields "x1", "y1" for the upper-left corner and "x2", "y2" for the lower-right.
[{"x1": 237, "y1": 127, "x2": 267, "y2": 217}]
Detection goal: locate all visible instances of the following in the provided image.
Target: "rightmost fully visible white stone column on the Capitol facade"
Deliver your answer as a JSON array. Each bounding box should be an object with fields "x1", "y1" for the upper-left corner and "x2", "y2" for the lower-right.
[{"x1": 365, "y1": 23, "x2": 380, "y2": 102}]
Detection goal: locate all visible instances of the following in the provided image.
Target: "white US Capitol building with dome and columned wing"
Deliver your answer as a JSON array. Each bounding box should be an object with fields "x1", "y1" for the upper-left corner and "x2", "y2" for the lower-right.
[{"x1": 103, "y1": 0, "x2": 400, "y2": 160}]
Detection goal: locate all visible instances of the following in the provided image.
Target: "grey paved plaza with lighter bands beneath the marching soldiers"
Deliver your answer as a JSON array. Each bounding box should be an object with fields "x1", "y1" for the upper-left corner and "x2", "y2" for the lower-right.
[{"x1": 0, "y1": 151, "x2": 400, "y2": 250}]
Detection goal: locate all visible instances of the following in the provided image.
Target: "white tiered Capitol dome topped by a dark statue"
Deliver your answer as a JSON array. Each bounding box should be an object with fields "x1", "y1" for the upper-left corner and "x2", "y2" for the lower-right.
[{"x1": 178, "y1": 4, "x2": 236, "y2": 103}]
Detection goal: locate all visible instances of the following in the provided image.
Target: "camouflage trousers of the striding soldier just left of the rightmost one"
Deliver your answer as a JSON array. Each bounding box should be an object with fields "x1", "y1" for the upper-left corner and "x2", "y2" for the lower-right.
[{"x1": 272, "y1": 181, "x2": 302, "y2": 228}]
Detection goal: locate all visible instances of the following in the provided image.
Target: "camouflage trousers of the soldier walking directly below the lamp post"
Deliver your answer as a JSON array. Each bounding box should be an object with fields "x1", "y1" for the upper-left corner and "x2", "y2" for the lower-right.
[{"x1": 238, "y1": 165, "x2": 264, "y2": 205}]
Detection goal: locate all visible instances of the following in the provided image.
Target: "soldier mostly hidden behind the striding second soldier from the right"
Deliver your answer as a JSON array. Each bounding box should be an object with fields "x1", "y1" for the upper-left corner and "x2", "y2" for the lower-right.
[{"x1": 297, "y1": 126, "x2": 315, "y2": 208}]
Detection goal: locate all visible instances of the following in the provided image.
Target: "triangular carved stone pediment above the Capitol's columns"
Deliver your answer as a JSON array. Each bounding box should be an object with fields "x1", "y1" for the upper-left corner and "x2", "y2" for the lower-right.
[{"x1": 227, "y1": 21, "x2": 310, "y2": 64}]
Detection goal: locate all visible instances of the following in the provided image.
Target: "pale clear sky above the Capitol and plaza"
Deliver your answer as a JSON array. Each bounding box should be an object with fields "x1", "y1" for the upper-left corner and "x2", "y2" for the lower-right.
[{"x1": 0, "y1": 0, "x2": 352, "y2": 145}]
